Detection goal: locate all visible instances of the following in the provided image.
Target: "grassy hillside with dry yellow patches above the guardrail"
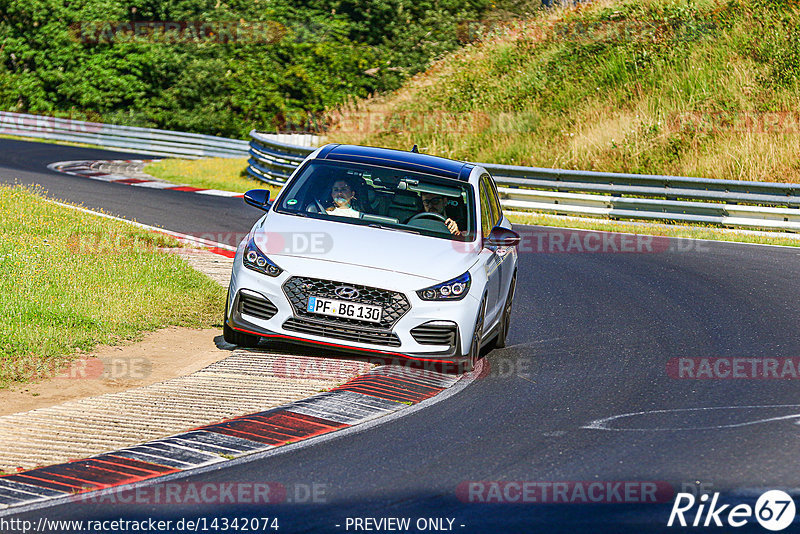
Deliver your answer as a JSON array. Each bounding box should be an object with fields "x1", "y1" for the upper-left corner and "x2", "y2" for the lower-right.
[{"x1": 330, "y1": 0, "x2": 800, "y2": 182}]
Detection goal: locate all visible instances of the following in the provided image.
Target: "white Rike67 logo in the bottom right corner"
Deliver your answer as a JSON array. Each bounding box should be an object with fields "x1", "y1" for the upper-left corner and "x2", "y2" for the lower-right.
[{"x1": 667, "y1": 490, "x2": 795, "y2": 531}]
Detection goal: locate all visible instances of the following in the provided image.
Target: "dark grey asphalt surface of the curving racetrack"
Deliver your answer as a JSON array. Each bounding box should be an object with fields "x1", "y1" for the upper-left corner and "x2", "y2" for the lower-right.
[{"x1": 0, "y1": 140, "x2": 800, "y2": 532}]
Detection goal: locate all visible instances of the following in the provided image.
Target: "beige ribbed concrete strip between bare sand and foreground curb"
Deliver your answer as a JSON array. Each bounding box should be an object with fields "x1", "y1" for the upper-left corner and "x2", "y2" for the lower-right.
[{"x1": 0, "y1": 349, "x2": 372, "y2": 472}]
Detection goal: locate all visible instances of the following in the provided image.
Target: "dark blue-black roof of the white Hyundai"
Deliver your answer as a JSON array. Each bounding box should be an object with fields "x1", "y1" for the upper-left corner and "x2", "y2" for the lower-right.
[{"x1": 317, "y1": 144, "x2": 475, "y2": 182}]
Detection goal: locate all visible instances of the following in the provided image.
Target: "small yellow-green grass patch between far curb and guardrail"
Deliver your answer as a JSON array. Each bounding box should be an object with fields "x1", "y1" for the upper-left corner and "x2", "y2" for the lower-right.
[{"x1": 144, "y1": 158, "x2": 280, "y2": 198}]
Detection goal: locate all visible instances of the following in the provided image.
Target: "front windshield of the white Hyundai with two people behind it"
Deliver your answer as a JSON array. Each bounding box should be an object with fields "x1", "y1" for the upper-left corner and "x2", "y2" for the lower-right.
[{"x1": 275, "y1": 160, "x2": 475, "y2": 241}]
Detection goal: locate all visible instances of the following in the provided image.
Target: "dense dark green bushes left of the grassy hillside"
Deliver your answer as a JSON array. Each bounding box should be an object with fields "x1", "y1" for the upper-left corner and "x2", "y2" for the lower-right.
[{"x1": 0, "y1": 0, "x2": 540, "y2": 138}]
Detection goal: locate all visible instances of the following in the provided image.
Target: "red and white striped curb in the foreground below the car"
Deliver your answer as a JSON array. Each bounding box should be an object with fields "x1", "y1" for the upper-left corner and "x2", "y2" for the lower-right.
[{"x1": 0, "y1": 360, "x2": 478, "y2": 512}]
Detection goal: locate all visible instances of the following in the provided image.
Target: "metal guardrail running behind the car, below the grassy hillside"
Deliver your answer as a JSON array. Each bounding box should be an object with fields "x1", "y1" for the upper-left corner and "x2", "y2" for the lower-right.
[{"x1": 248, "y1": 130, "x2": 800, "y2": 231}]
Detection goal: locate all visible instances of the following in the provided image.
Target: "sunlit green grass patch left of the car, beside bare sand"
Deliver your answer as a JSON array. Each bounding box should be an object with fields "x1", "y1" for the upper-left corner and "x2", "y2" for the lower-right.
[{"x1": 0, "y1": 186, "x2": 225, "y2": 387}]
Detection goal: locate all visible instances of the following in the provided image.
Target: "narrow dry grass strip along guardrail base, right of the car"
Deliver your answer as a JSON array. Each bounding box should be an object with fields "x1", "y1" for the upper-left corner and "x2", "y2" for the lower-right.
[{"x1": 507, "y1": 212, "x2": 800, "y2": 247}]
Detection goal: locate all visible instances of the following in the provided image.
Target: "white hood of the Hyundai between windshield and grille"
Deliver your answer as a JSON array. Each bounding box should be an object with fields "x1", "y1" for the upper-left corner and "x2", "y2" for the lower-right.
[{"x1": 254, "y1": 212, "x2": 479, "y2": 282}]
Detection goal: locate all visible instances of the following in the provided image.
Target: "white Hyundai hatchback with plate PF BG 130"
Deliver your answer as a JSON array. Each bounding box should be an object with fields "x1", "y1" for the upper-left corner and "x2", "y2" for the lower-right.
[{"x1": 224, "y1": 145, "x2": 519, "y2": 369}]
